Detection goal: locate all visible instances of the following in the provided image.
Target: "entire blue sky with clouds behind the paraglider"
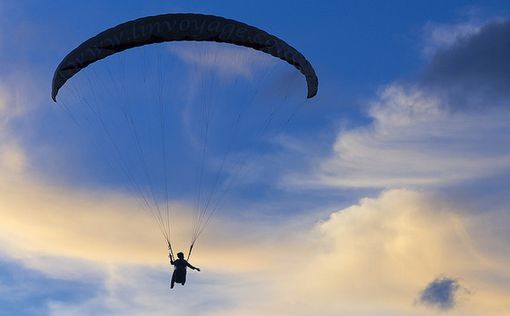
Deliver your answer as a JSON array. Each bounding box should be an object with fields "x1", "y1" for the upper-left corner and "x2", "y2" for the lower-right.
[{"x1": 0, "y1": 0, "x2": 510, "y2": 316}]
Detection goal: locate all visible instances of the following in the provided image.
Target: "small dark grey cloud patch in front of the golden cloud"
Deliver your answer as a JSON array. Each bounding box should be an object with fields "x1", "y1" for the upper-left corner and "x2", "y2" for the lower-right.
[{"x1": 419, "y1": 277, "x2": 460, "y2": 310}]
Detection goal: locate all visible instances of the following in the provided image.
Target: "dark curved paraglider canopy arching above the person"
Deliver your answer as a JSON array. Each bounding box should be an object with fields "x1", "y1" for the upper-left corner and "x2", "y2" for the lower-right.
[{"x1": 51, "y1": 13, "x2": 318, "y2": 101}]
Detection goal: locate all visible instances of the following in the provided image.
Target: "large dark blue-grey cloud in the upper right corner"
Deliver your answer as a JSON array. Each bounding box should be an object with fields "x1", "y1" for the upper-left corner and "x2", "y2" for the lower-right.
[{"x1": 420, "y1": 20, "x2": 510, "y2": 109}]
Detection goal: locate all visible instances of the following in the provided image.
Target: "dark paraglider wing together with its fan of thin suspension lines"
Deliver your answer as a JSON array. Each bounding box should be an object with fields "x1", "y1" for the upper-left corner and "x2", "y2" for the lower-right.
[{"x1": 52, "y1": 14, "x2": 318, "y2": 260}]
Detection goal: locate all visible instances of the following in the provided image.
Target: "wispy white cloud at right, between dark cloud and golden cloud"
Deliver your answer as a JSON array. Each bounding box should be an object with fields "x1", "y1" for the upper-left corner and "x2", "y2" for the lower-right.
[{"x1": 289, "y1": 84, "x2": 510, "y2": 188}]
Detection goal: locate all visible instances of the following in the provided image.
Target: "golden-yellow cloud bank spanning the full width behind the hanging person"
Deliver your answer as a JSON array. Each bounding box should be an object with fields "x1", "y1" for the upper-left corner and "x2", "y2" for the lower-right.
[{"x1": 0, "y1": 156, "x2": 510, "y2": 315}]
